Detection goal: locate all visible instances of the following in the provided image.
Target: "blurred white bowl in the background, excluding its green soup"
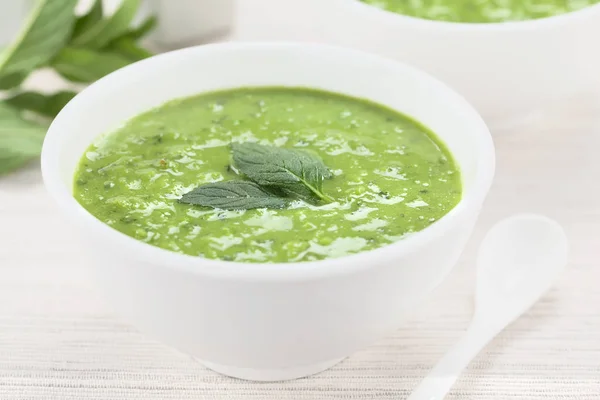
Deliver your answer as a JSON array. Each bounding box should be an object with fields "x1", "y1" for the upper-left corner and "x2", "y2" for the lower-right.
[{"x1": 323, "y1": 0, "x2": 600, "y2": 128}]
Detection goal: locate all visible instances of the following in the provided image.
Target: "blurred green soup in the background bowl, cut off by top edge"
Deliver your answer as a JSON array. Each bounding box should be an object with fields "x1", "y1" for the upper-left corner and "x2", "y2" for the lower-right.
[{"x1": 361, "y1": 0, "x2": 600, "y2": 23}]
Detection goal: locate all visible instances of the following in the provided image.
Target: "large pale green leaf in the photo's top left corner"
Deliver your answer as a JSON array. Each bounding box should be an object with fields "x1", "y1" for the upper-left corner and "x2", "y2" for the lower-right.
[{"x1": 0, "y1": 0, "x2": 77, "y2": 76}]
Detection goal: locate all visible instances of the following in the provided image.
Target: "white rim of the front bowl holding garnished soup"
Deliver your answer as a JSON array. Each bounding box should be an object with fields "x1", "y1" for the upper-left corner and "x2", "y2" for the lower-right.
[{"x1": 41, "y1": 42, "x2": 495, "y2": 281}]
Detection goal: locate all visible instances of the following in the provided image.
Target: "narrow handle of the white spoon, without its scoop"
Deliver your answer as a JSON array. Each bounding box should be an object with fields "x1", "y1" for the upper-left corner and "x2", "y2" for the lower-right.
[{"x1": 407, "y1": 321, "x2": 498, "y2": 400}]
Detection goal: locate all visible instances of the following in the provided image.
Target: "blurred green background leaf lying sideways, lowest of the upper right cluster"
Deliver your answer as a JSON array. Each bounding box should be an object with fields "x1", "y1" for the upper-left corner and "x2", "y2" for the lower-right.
[{"x1": 51, "y1": 47, "x2": 131, "y2": 83}]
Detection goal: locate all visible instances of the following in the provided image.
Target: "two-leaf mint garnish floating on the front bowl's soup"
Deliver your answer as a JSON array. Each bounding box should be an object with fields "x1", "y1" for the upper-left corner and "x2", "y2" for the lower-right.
[{"x1": 179, "y1": 143, "x2": 334, "y2": 210}]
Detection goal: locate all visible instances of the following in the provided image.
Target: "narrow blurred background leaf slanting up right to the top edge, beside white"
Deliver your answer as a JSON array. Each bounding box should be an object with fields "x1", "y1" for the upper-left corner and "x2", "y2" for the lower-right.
[{"x1": 72, "y1": 0, "x2": 141, "y2": 49}]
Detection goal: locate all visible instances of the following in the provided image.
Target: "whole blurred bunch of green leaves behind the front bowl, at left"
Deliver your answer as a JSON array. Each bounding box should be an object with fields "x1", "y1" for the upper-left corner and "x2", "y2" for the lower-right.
[{"x1": 0, "y1": 0, "x2": 156, "y2": 174}]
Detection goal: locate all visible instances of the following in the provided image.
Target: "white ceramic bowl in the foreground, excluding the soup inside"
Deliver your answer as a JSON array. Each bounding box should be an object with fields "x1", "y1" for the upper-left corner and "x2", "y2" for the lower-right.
[{"x1": 42, "y1": 43, "x2": 494, "y2": 380}]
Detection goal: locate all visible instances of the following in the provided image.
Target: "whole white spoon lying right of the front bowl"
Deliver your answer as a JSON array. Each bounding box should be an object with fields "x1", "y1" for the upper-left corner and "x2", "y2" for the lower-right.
[{"x1": 408, "y1": 214, "x2": 568, "y2": 400}]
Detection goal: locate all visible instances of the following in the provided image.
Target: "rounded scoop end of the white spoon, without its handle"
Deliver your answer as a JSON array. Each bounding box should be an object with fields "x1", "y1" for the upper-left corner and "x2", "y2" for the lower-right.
[{"x1": 475, "y1": 214, "x2": 568, "y2": 325}]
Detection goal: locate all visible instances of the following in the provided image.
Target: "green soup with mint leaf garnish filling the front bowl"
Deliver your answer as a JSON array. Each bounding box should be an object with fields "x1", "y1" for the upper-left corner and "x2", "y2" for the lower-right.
[{"x1": 74, "y1": 88, "x2": 461, "y2": 262}]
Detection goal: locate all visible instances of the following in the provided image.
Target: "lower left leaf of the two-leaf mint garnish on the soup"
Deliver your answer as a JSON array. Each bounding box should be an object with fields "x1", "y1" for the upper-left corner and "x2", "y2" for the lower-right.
[{"x1": 179, "y1": 181, "x2": 287, "y2": 210}]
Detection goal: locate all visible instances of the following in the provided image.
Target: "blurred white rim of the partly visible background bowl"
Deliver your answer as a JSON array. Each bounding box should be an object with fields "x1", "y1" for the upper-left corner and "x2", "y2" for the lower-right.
[{"x1": 342, "y1": 0, "x2": 600, "y2": 32}]
